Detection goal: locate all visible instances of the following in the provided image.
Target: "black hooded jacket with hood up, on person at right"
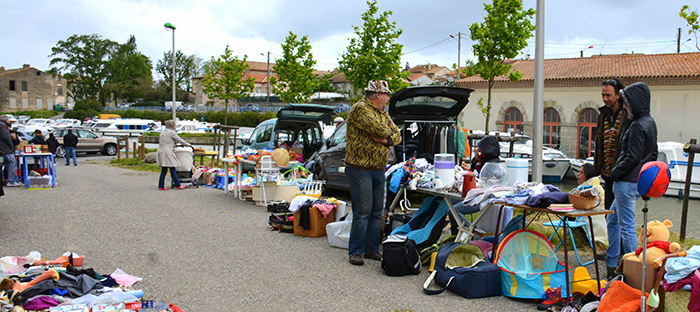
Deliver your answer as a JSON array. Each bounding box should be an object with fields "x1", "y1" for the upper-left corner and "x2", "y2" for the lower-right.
[{"x1": 610, "y1": 82, "x2": 659, "y2": 183}]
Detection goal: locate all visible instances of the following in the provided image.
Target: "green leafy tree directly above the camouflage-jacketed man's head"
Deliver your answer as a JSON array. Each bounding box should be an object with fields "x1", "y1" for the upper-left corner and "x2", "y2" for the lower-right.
[{"x1": 338, "y1": 0, "x2": 408, "y2": 96}]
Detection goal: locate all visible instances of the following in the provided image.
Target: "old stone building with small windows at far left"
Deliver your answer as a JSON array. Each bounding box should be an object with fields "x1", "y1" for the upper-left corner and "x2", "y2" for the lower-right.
[{"x1": 0, "y1": 64, "x2": 72, "y2": 112}]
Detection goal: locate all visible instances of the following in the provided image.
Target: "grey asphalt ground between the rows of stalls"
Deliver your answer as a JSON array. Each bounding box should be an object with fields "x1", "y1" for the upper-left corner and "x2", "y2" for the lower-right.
[{"x1": 0, "y1": 155, "x2": 536, "y2": 312}]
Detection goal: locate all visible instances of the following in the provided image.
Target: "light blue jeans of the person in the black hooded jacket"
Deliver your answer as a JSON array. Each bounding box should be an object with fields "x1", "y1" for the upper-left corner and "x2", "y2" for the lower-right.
[{"x1": 605, "y1": 181, "x2": 639, "y2": 267}]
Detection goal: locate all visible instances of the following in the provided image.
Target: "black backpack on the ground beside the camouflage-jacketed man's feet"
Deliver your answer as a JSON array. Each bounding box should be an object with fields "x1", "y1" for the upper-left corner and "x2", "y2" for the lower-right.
[{"x1": 382, "y1": 234, "x2": 423, "y2": 276}]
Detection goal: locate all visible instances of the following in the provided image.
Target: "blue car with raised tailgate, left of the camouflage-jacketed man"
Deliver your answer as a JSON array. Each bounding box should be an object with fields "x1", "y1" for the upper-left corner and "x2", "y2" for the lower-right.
[{"x1": 243, "y1": 104, "x2": 333, "y2": 170}]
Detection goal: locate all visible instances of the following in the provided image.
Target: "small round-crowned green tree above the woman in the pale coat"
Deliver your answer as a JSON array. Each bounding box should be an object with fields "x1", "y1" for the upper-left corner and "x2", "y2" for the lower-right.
[{"x1": 202, "y1": 45, "x2": 255, "y2": 124}]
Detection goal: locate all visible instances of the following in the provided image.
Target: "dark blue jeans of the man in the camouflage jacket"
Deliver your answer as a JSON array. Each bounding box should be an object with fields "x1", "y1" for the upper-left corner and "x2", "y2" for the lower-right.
[{"x1": 345, "y1": 167, "x2": 386, "y2": 255}]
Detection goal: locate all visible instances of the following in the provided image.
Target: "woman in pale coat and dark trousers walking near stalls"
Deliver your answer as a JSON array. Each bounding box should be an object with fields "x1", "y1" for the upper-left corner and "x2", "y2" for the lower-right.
[{"x1": 156, "y1": 120, "x2": 191, "y2": 191}]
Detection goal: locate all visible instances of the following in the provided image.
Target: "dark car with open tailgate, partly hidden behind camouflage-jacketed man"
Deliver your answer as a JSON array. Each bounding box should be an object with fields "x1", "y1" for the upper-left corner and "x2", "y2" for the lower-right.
[{"x1": 307, "y1": 86, "x2": 474, "y2": 190}]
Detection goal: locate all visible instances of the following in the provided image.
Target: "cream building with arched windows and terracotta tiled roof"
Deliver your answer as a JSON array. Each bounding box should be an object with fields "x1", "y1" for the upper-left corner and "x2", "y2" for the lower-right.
[{"x1": 455, "y1": 53, "x2": 700, "y2": 158}]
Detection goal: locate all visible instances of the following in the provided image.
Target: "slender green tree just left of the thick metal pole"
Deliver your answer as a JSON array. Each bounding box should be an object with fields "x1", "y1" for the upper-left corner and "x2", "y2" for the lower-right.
[{"x1": 464, "y1": 0, "x2": 535, "y2": 133}]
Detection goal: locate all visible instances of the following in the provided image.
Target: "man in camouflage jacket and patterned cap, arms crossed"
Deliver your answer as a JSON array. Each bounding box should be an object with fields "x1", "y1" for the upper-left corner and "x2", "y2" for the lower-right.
[{"x1": 345, "y1": 80, "x2": 401, "y2": 265}]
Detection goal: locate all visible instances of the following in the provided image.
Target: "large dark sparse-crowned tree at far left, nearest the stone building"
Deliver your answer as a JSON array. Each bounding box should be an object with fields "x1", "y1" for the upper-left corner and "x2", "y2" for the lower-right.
[{"x1": 49, "y1": 34, "x2": 119, "y2": 100}]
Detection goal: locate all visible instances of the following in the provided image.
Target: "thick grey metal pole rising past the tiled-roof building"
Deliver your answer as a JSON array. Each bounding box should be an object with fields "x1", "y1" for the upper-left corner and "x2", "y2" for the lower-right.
[{"x1": 532, "y1": 0, "x2": 544, "y2": 181}]
